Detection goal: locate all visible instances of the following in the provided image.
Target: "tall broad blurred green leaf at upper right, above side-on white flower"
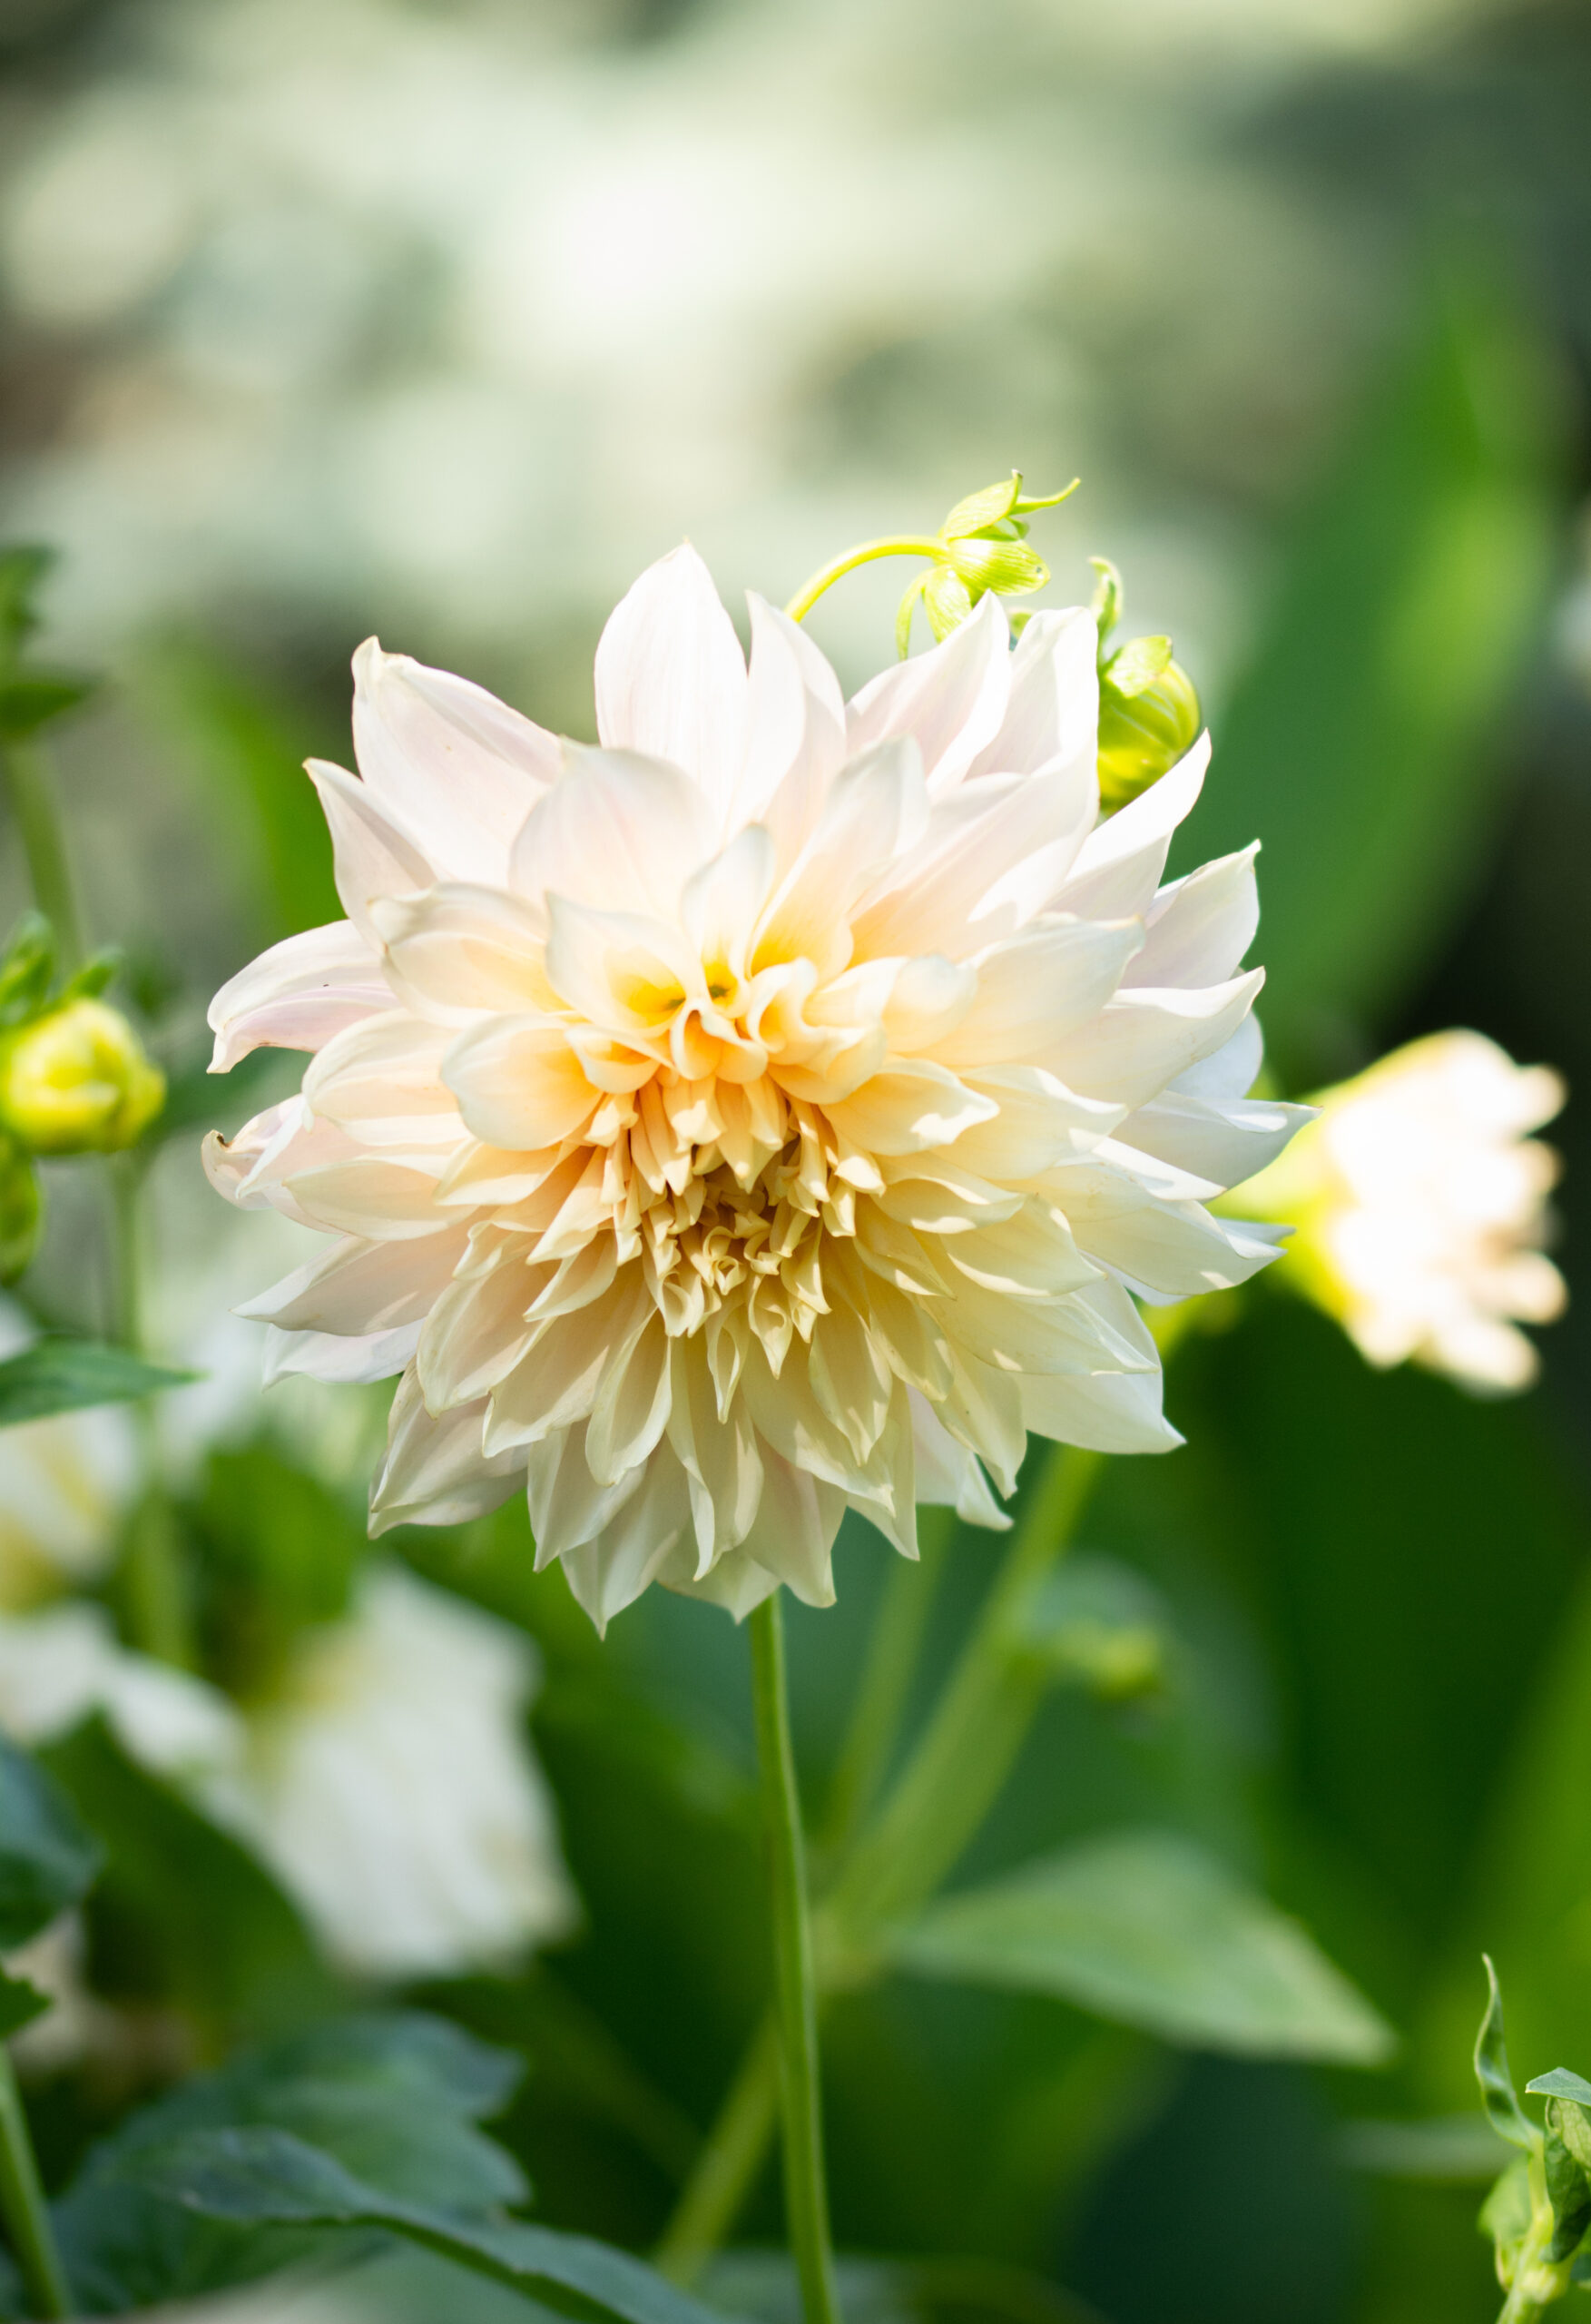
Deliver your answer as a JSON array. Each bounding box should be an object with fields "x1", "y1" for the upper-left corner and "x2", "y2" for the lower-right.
[{"x1": 1173, "y1": 272, "x2": 1558, "y2": 1086}]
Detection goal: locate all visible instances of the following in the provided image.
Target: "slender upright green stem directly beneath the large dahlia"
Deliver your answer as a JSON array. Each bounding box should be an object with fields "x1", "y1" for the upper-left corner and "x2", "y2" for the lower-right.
[{"x1": 751, "y1": 1590, "x2": 839, "y2": 2324}]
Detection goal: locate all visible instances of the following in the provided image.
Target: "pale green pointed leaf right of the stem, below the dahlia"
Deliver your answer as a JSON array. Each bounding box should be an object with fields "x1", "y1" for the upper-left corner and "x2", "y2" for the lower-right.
[{"x1": 892, "y1": 1831, "x2": 1393, "y2": 2066}]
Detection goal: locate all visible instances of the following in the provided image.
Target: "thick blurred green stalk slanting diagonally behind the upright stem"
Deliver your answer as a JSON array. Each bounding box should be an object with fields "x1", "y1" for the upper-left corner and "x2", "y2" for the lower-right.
[{"x1": 660, "y1": 1445, "x2": 1104, "y2": 2282}]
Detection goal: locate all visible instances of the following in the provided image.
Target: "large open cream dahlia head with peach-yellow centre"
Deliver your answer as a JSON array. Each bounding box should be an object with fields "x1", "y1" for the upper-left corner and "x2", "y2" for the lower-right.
[{"x1": 207, "y1": 548, "x2": 1299, "y2": 1624}]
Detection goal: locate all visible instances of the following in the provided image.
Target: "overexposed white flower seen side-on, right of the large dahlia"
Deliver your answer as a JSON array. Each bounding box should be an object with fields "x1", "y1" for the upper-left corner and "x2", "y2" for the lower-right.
[{"x1": 1235, "y1": 1032, "x2": 1566, "y2": 1390}]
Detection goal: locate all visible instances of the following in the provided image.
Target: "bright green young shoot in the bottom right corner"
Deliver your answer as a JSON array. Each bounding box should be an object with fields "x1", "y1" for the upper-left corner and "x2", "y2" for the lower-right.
[{"x1": 1475, "y1": 1959, "x2": 1591, "y2": 2324}]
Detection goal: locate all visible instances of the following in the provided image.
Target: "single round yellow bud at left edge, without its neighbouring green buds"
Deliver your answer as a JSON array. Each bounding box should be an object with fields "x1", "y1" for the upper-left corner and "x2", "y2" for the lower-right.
[{"x1": 0, "y1": 1000, "x2": 165, "y2": 1155}]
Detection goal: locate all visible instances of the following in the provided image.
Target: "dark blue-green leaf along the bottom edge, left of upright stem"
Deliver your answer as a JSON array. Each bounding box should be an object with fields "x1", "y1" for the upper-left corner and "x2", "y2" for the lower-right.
[{"x1": 102, "y1": 2129, "x2": 733, "y2": 2324}]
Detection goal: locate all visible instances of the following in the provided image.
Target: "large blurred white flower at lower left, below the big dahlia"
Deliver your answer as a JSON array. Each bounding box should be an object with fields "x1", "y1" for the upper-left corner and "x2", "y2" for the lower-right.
[{"x1": 207, "y1": 1571, "x2": 576, "y2": 1978}]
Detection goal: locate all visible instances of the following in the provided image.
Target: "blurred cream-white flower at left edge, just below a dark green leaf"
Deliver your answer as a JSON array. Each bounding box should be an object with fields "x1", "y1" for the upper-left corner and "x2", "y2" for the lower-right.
[{"x1": 0, "y1": 1299, "x2": 140, "y2": 1609}]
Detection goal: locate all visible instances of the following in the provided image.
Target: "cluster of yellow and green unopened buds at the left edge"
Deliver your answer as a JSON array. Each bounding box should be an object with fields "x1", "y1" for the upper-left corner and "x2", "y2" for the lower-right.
[{"x1": 0, "y1": 913, "x2": 165, "y2": 1283}]
